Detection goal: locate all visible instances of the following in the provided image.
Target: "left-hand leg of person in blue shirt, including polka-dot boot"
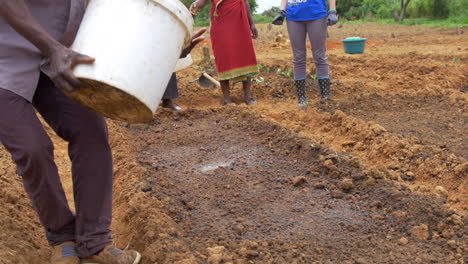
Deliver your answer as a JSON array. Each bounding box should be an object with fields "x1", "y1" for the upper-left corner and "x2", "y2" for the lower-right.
[{"x1": 287, "y1": 20, "x2": 307, "y2": 106}]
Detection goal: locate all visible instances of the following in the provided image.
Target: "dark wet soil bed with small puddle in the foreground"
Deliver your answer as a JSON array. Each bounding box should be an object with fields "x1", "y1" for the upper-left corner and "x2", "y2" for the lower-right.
[{"x1": 126, "y1": 107, "x2": 464, "y2": 263}]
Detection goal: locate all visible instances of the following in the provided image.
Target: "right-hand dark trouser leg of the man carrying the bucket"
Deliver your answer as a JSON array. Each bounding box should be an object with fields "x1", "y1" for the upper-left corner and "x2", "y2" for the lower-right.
[{"x1": 33, "y1": 74, "x2": 113, "y2": 257}]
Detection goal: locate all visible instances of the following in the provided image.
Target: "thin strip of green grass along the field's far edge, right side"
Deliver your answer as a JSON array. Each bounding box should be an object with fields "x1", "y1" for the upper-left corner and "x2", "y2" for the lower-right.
[{"x1": 340, "y1": 17, "x2": 468, "y2": 27}]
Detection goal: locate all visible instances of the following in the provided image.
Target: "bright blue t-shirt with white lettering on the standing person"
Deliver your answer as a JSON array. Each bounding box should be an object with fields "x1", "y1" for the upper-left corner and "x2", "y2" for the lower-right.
[{"x1": 286, "y1": 0, "x2": 327, "y2": 21}]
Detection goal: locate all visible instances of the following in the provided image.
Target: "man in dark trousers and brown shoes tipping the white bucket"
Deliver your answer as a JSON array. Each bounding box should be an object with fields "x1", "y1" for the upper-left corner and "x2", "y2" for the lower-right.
[{"x1": 0, "y1": 0, "x2": 204, "y2": 264}]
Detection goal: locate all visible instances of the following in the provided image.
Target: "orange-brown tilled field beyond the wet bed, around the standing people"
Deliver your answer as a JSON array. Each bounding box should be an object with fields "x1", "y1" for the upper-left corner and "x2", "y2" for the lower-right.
[{"x1": 178, "y1": 23, "x2": 468, "y2": 213}]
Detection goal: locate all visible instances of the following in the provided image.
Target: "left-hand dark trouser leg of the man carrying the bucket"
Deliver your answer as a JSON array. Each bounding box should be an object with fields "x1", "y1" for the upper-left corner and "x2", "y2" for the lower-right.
[{"x1": 0, "y1": 89, "x2": 75, "y2": 246}]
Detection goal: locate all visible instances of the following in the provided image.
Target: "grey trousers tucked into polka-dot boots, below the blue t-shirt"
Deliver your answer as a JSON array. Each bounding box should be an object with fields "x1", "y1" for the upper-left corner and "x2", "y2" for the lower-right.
[{"x1": 287, "y1": 17, "x2": 329, "y2": 80}]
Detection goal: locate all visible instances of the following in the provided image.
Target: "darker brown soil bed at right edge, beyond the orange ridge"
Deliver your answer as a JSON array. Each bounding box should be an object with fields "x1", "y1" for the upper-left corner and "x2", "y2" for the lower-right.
[{"x1": 319, "y1": 94, "x2": 468, "y2": 159}]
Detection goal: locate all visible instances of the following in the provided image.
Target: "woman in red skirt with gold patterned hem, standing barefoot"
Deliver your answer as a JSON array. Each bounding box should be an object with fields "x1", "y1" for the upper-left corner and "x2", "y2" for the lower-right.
[{"x1": 190, "y1": 0, "x2": 258, "y2": 105}]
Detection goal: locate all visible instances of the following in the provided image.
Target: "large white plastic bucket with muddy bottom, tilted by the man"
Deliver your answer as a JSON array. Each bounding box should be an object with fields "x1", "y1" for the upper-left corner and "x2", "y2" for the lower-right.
[{"x1": 67, "y1": 0, "x2": 193, "y2": 123}]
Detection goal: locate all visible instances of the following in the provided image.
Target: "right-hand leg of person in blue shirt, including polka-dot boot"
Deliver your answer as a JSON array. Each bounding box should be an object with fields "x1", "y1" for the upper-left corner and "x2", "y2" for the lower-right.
[{"x1": 307, "y1": 17, "x2": 330, "y2": 99}]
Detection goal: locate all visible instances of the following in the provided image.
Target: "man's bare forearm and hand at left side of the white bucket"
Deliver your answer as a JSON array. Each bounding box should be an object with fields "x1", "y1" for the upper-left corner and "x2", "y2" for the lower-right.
[{"x1": 0, "y1": 0, "x2": 94, "y2": 91}]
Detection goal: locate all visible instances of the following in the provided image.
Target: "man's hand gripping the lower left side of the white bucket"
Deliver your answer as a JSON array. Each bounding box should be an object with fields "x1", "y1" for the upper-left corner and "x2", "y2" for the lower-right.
[{"x1": 48, "y1": 46, "x2": 94, "y2": 92}]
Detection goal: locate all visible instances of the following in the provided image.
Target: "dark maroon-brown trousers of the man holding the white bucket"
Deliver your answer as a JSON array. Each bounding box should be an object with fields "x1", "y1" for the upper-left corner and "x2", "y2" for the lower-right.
[{"x1": 0, "y1": 74, "x2": 113, "y2": 257}]
